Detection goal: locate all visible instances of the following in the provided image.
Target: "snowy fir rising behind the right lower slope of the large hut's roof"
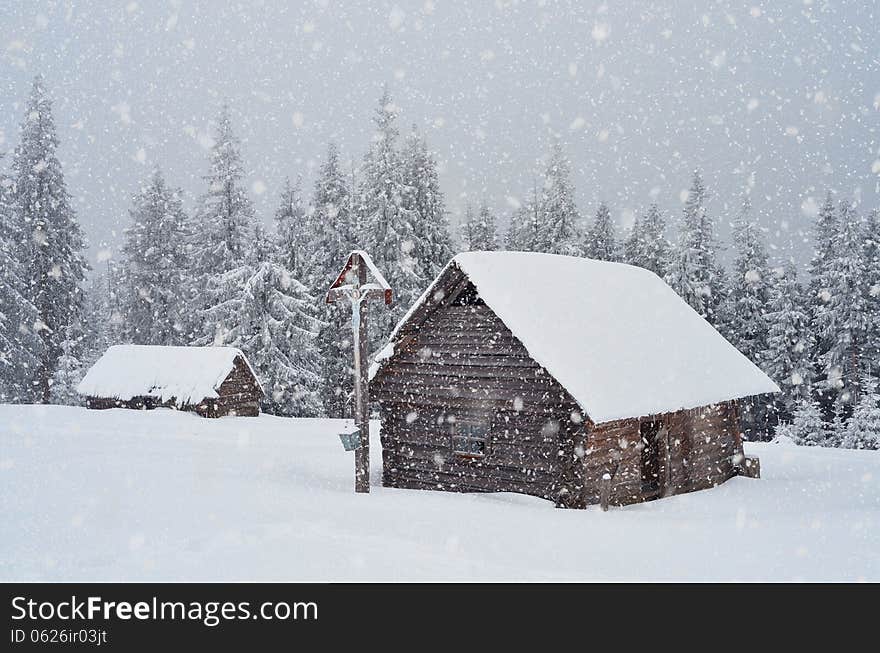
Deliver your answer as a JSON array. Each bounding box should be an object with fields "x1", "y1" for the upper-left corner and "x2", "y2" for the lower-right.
[{"x1": 723, "y1": 198, "x2": 770, "y2": 368}]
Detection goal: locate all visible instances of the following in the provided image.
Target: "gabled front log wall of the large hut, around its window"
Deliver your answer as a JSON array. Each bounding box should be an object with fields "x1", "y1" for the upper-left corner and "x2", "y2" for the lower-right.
[{"x1": 371, "y1": 280, "x2": 583, "y2": 504}]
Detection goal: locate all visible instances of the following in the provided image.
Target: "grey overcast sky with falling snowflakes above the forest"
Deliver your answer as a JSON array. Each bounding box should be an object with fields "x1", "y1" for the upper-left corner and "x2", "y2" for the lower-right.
[{"x1": 0, "y1": 0, "x2": 880, "y2": 270}]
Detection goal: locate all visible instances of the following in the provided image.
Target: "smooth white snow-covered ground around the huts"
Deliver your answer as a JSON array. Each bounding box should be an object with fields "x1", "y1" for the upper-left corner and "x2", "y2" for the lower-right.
[{"x1": 0, "y1": 405, "x2": 880, "y2": 581}]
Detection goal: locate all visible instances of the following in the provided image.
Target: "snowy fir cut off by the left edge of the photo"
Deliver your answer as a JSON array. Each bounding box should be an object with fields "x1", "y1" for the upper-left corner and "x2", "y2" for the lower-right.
[{"x1": 0, "y1": 160, "x2": 39, "y2": 403}]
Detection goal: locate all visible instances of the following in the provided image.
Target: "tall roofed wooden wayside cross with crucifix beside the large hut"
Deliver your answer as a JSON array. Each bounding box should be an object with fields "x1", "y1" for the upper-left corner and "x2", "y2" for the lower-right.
[{"x1": 327, "y1": 250, "x2": 391, "y2": 492}]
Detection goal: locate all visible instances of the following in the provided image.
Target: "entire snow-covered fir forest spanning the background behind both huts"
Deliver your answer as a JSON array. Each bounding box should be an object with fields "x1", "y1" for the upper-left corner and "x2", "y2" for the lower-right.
[{"x1": 0, "y1": 77, "x2": 880, "y2": 448}]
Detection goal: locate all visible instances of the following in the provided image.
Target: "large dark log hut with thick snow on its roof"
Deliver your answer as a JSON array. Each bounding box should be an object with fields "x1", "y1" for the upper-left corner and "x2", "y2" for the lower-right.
[{"x1": 370, "y1": 252, "x2": 779, "y2": 508}]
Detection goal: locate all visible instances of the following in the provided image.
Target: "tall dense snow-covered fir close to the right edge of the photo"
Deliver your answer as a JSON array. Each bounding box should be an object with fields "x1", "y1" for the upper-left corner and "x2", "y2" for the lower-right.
[{"x1": 814, "y1": 201, "x2": 876, "y2": 405}]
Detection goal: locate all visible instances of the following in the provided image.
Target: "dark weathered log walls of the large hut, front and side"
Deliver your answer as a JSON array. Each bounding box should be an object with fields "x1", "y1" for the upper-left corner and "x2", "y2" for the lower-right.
[{"x1": 371, "y1": 270, "x2": 741, "y2": 508}]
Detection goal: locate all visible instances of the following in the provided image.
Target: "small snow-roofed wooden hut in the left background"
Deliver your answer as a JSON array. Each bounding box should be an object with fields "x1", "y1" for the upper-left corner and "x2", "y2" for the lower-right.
[{"x1": 77, "y1": 345, "x2": 263, "y2": 417}]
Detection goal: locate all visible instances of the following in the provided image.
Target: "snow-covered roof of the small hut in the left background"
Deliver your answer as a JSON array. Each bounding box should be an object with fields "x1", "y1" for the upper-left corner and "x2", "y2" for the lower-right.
[{"x1": 76, "y1": 345, "x2": 259, "y2": 405}]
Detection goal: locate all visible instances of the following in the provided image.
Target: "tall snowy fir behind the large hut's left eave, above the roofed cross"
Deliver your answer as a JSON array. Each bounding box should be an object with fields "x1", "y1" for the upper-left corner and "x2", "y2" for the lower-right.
[{"x1": 358, "y1": 88, "x2": 430, "y2": 334}]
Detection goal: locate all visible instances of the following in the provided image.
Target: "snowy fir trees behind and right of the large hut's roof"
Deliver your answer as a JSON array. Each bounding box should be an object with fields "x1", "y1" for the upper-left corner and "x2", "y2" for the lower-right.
[{"x1": 463, "y1": 161, "x2": 880, "y2": 449}]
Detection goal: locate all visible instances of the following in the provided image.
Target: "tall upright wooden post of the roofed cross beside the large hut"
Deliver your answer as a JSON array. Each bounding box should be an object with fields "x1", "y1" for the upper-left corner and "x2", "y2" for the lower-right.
[{"x1": 351, "y1": 256, "x2": 370, "y2": 493}]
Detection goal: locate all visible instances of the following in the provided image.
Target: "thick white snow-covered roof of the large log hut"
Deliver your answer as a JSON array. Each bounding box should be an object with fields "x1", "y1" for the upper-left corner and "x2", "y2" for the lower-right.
[{"x1": 371, "y1": 252, "x2": 779, "y2": 423}]
